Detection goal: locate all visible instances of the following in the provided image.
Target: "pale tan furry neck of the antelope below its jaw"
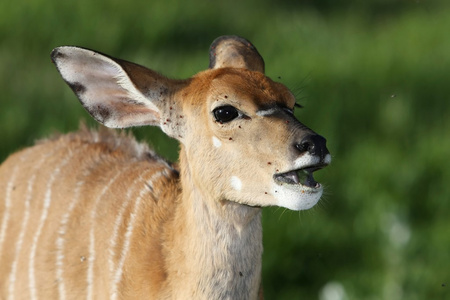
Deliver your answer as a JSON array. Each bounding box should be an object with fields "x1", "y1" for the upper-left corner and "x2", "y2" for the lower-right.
[{"x1": 163, "y1": 151, "x2": 262, "y2": 299}]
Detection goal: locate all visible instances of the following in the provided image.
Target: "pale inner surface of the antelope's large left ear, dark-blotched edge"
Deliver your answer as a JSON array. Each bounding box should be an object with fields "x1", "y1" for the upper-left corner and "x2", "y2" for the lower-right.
[{"x1": 56, "y1": 47, "x2": 161, "y2": 127}]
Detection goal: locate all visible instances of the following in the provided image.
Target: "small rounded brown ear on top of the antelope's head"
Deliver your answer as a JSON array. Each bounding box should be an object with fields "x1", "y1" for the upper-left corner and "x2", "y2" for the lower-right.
[{"x1": 209, "y1": 35, "x2": 264, "y2": 73}]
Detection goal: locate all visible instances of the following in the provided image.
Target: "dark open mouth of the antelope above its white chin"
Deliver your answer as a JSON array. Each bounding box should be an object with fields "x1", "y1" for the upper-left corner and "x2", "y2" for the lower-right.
[{"x1": 274, "y1": 165, "x2": 325, "y2": 189}]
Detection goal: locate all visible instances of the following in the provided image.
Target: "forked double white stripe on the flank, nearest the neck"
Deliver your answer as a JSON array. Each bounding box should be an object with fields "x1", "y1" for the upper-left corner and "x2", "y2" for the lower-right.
[{"x1": 109, "y1": 168, "x2": 167, "y2": 300}]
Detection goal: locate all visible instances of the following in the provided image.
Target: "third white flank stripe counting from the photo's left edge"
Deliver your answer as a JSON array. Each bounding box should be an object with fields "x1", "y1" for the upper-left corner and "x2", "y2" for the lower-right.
[{"x1": 28, "y1": 152, "x2": 73, "y2": 299}]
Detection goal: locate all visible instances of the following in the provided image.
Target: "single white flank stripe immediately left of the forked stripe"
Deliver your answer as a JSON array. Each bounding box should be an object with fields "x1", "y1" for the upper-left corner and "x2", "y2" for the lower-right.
[{"x1": 87, "y1": 170, "x2": 123, "y2": 300}]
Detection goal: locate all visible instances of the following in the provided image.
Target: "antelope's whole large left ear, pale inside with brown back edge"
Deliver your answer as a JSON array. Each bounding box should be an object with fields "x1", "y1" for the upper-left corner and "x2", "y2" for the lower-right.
[{"x1": 51, "y1": 47, "x2": 178, "y2": 131}]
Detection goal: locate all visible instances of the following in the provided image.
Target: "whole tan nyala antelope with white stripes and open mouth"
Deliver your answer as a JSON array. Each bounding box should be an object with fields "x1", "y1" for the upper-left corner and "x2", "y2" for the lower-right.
[{"x1": 0, "y1": 36, "x2": 331, "y2": 300}]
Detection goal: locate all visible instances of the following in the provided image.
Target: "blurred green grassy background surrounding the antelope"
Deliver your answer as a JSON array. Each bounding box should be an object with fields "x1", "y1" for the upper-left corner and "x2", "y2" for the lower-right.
[{"x1": 0, "y1": 0, "x2": 450, "y2": 300}]
